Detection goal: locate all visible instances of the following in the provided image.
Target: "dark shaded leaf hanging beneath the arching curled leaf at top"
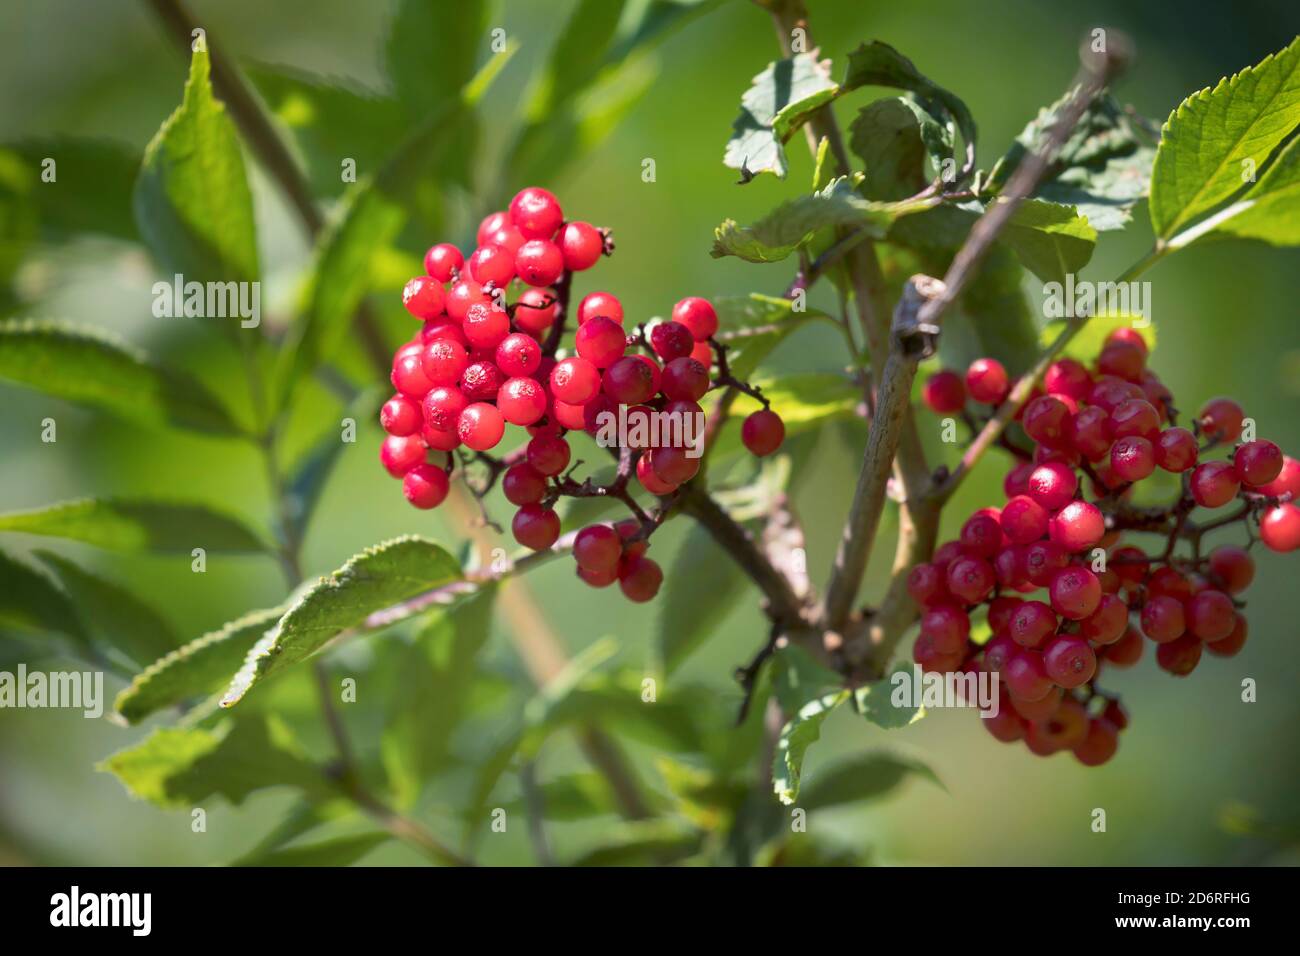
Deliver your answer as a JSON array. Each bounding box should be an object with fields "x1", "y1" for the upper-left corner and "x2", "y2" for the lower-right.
[{"x1": 849, "y1": 95, "x2": 953, "y2": 200}]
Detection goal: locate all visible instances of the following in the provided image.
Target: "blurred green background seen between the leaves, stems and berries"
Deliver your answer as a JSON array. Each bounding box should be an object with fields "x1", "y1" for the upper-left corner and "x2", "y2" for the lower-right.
[{"x1": 0, "y1": 0, "x2": 1300, "y2": 865}]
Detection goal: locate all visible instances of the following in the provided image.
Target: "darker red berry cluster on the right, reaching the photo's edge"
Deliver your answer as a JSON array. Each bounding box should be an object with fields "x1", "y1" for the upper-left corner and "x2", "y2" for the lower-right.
[{"x1": 907, "y1": 328, "x2": 1300, "y2": 766}]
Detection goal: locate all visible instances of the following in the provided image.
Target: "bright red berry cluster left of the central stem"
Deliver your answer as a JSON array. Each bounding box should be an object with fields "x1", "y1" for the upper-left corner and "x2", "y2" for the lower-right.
[{"x1": 380, "y1": 187, "x2": 785, "y2": 601}]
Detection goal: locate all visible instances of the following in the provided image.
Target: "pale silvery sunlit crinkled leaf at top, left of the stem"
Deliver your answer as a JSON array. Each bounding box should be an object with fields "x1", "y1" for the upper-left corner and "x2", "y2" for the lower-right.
[{"x1": 723, "y1": 53, "x2": 839, "y2": 179}]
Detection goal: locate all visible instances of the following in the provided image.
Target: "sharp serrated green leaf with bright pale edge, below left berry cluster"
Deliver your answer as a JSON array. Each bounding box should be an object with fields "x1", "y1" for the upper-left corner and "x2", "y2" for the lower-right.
[{"x1": 221, "y1": 536, "x2": 460, "y2": 708}]
